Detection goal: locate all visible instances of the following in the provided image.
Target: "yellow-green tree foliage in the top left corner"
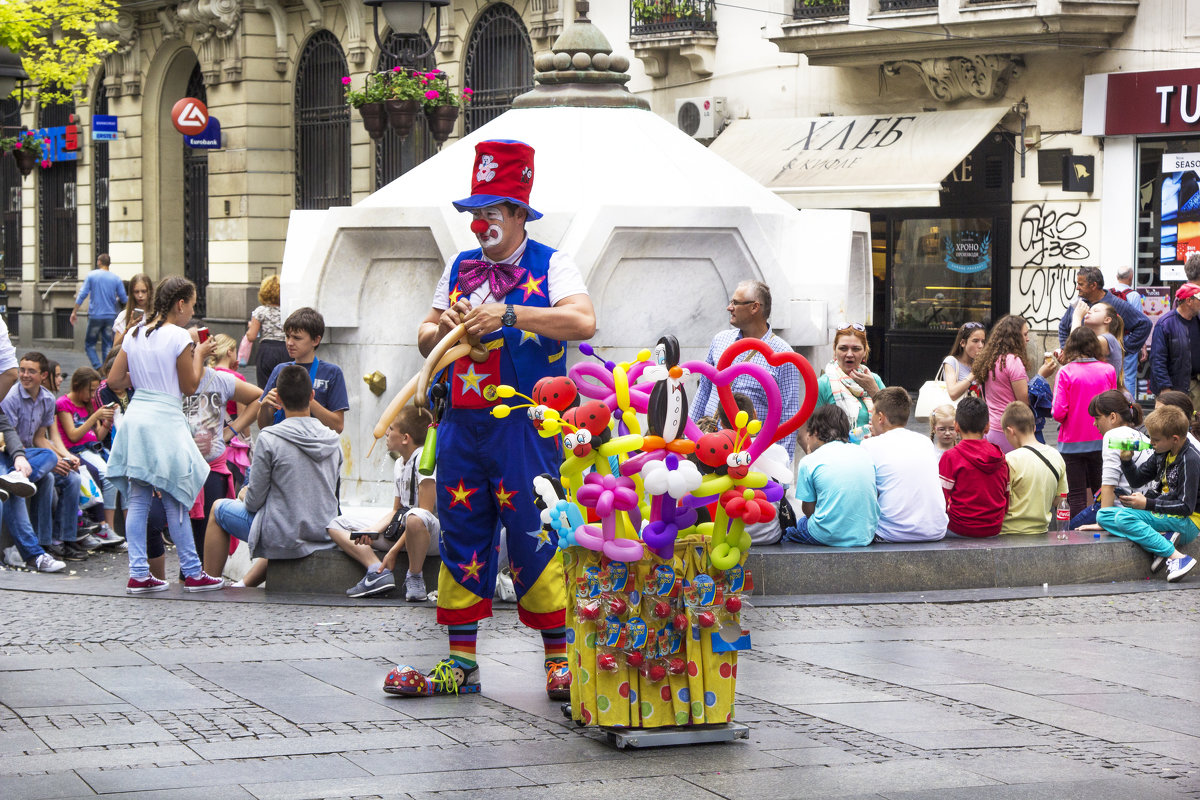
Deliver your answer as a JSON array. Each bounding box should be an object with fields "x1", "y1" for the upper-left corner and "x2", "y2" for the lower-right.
[{"x1": 0, "y1": 0, "x2": 118, "y2": 104}]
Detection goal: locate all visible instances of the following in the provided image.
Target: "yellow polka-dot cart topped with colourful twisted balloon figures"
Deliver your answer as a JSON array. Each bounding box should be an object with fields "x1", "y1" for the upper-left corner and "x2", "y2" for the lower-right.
[{"x1": 491, "y1": 336, "x2": 817, "y2": 728}]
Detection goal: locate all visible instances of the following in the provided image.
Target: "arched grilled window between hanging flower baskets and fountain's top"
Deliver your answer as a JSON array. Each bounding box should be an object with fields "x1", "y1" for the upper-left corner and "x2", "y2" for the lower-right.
[{"x1": 464, "y1": 4, "x2": 533, "y2": 133}]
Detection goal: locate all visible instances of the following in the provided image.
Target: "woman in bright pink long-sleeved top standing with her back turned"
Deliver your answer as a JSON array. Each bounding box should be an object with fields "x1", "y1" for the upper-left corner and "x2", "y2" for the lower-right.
[{"x1": 1051, "y1": 327, "x2": 1117, "y2": 517}]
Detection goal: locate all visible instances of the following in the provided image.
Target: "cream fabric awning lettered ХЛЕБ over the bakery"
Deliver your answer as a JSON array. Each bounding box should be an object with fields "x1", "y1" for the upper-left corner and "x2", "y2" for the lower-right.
[{"x1": 709, "y1": 107, "x2": 1008, "y2": 209}]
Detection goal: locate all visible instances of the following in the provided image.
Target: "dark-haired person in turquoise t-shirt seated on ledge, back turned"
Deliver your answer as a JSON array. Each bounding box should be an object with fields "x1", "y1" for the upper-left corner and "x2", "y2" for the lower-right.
[{"x1": 784, "y1": 405, "x2": 880, "y2": 547}]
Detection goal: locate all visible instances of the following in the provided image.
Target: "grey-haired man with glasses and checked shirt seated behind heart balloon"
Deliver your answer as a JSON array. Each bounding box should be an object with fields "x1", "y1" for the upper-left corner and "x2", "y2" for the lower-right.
[{"x1": 691, "y1": 281, "x2": 800, "y2": 457}]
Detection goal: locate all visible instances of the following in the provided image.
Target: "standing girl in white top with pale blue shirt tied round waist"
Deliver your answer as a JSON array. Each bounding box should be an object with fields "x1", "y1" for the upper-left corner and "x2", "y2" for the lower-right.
[{"x1": 108, "y1": 276, "x2": 224, "y2": 595}]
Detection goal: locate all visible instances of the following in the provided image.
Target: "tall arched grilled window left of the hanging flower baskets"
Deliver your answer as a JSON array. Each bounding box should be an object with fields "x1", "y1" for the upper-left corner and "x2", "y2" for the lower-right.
[{"x1": 295, "y1": 30, "x2": 350, "y2": 209}]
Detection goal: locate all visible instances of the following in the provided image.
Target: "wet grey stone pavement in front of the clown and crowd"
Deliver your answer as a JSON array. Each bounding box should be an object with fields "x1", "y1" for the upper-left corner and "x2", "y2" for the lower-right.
[{"x1": 0, "y1": 557, "x2": 1200, "y2": 800}]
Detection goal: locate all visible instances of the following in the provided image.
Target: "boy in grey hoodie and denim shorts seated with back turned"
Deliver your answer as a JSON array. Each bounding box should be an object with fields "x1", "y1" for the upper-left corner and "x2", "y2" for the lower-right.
[{"x1": 204, "y1": 365, "x2": 342, "y2": 575}]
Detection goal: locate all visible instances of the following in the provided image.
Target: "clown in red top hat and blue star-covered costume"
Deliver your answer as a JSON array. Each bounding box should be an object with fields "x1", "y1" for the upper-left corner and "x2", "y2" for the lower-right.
[{"x1": 384, "y1": 140, "x2": 595, "y2": 699}]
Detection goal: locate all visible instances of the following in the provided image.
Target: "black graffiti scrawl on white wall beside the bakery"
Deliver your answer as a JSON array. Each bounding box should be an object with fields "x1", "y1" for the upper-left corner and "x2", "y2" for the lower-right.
[{"x1": 1010, "y1": 200, "x2": 1100, "y2": 331}]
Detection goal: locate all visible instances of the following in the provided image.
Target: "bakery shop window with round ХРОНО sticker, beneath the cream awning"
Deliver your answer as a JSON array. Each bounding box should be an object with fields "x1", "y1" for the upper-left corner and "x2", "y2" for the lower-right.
[{"x1": 890, "y1": 217, "x2": 995, "y2": 331}]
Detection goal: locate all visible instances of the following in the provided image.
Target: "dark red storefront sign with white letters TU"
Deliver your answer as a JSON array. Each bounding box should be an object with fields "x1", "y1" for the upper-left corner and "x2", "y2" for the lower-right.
[{"x1": 1099, "y1": 70, "x2": 1200, "y2": 136}]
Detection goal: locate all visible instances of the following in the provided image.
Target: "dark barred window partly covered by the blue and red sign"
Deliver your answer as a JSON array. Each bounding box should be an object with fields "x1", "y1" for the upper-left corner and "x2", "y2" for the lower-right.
[{"x1": 37, "y1": 95, "x2": 79, "y2": 281}]
